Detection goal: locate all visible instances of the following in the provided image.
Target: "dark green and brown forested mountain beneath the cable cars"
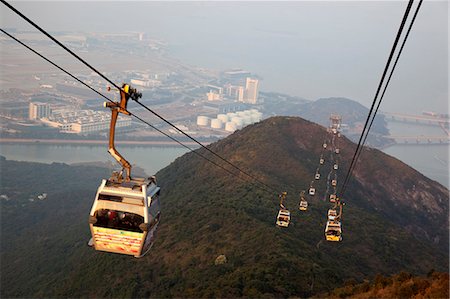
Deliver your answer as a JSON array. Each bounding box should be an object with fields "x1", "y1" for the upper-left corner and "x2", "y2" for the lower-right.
[{"x1": 0, "y1": 117, "x2": 449, "y2": 297}]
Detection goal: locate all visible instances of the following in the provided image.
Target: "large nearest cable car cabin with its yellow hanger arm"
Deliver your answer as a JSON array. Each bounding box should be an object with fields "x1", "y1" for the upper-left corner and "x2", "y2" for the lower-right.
[{"x1": 88, "y1": 84, "x2": 161, "y2": 257}]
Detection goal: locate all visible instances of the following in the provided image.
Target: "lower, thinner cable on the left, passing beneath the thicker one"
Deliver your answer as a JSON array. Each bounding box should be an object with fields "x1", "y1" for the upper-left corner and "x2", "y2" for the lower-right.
[{"x1": 0, "y1": 28, "x2": 271, "y2": 193}]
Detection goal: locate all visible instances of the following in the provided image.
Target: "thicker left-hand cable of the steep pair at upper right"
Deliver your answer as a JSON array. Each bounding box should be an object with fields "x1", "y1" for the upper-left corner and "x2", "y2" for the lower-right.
[{"x1": 340, "y1": 0, "x2": 414, "y2": 197}]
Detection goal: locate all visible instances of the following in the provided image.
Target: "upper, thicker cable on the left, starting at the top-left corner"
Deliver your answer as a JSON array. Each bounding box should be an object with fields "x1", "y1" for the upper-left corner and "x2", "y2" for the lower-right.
[{"x1": 1, "y1": 0, "x2": 279, "y2": 194}]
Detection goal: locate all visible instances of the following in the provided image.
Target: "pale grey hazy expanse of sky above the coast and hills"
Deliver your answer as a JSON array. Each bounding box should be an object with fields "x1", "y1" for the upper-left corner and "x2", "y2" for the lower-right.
[{"x1": 0, "y1": 1, "x2": 449, "y2": 113}]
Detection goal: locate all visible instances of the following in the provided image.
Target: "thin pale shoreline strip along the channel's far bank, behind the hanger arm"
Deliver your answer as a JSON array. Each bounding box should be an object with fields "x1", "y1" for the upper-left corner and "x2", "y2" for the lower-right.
[{"x1": 0, "y1": 138, "x2": 210, "y2": 148}]
